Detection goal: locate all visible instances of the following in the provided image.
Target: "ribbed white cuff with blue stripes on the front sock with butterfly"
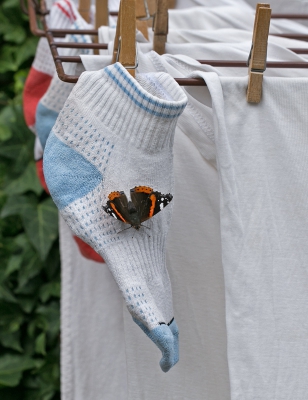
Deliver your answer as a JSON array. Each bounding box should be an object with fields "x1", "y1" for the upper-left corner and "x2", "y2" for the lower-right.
[{"x1": 70, "y1": 63, "x2": 187, "y2": 152}]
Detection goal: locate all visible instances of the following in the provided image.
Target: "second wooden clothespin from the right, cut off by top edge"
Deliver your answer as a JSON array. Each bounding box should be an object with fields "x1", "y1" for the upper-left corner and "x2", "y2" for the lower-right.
[{"x1": 153, "y1": 0, "x2": 168, "y2": 55}]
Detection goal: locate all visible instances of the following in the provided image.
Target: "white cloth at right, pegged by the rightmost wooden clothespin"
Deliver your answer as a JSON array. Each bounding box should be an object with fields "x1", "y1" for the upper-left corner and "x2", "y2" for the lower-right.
[{"x1": 194, "y1": 74, "x2": 308, "y2": 400}]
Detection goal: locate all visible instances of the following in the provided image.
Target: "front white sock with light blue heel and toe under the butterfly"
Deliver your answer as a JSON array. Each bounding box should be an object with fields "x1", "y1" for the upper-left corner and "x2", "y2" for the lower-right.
[{"x1": 44, "y1": 64, "x2": 187, "y2": 371}]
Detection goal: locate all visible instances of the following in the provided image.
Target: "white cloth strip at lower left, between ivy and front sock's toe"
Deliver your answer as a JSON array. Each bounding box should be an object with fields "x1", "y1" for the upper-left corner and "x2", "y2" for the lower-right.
[{"x1": 60, "y1": 218, "x2": 128, "y2": 400}]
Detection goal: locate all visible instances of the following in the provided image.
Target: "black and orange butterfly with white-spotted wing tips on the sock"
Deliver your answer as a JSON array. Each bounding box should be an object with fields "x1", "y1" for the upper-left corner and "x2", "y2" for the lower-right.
[{"x1": 103, "y1": 186, "x2": 173, "y2": 230}]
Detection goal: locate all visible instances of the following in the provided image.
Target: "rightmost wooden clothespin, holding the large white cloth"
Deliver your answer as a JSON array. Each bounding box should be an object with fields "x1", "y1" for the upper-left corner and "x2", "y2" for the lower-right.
[{"x1": 246, "y1": 3, "x2": 272, "y2": 103}]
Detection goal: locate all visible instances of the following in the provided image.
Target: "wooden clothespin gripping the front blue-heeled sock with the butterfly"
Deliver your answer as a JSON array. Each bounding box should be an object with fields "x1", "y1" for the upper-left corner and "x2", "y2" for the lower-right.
[{"x1": 113, "y1": 0, "x2": 137, "y2": 77}]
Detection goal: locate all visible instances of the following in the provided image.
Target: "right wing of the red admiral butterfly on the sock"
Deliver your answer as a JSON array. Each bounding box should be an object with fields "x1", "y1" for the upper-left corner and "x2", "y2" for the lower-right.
[{"x1": 130, "y1": 186, "x2": 173, "y2": 222}]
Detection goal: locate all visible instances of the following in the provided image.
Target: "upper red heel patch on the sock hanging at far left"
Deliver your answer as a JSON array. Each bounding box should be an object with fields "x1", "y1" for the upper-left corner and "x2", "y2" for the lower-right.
[{"x1": 23, "y1": 67, "x2": 52, "y2": 126}]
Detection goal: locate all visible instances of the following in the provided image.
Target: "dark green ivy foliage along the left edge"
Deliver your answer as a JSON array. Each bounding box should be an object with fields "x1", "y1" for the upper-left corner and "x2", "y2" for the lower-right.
[{"x1": 0, "y1": 0, "x2": 60, "y2": 400}]
